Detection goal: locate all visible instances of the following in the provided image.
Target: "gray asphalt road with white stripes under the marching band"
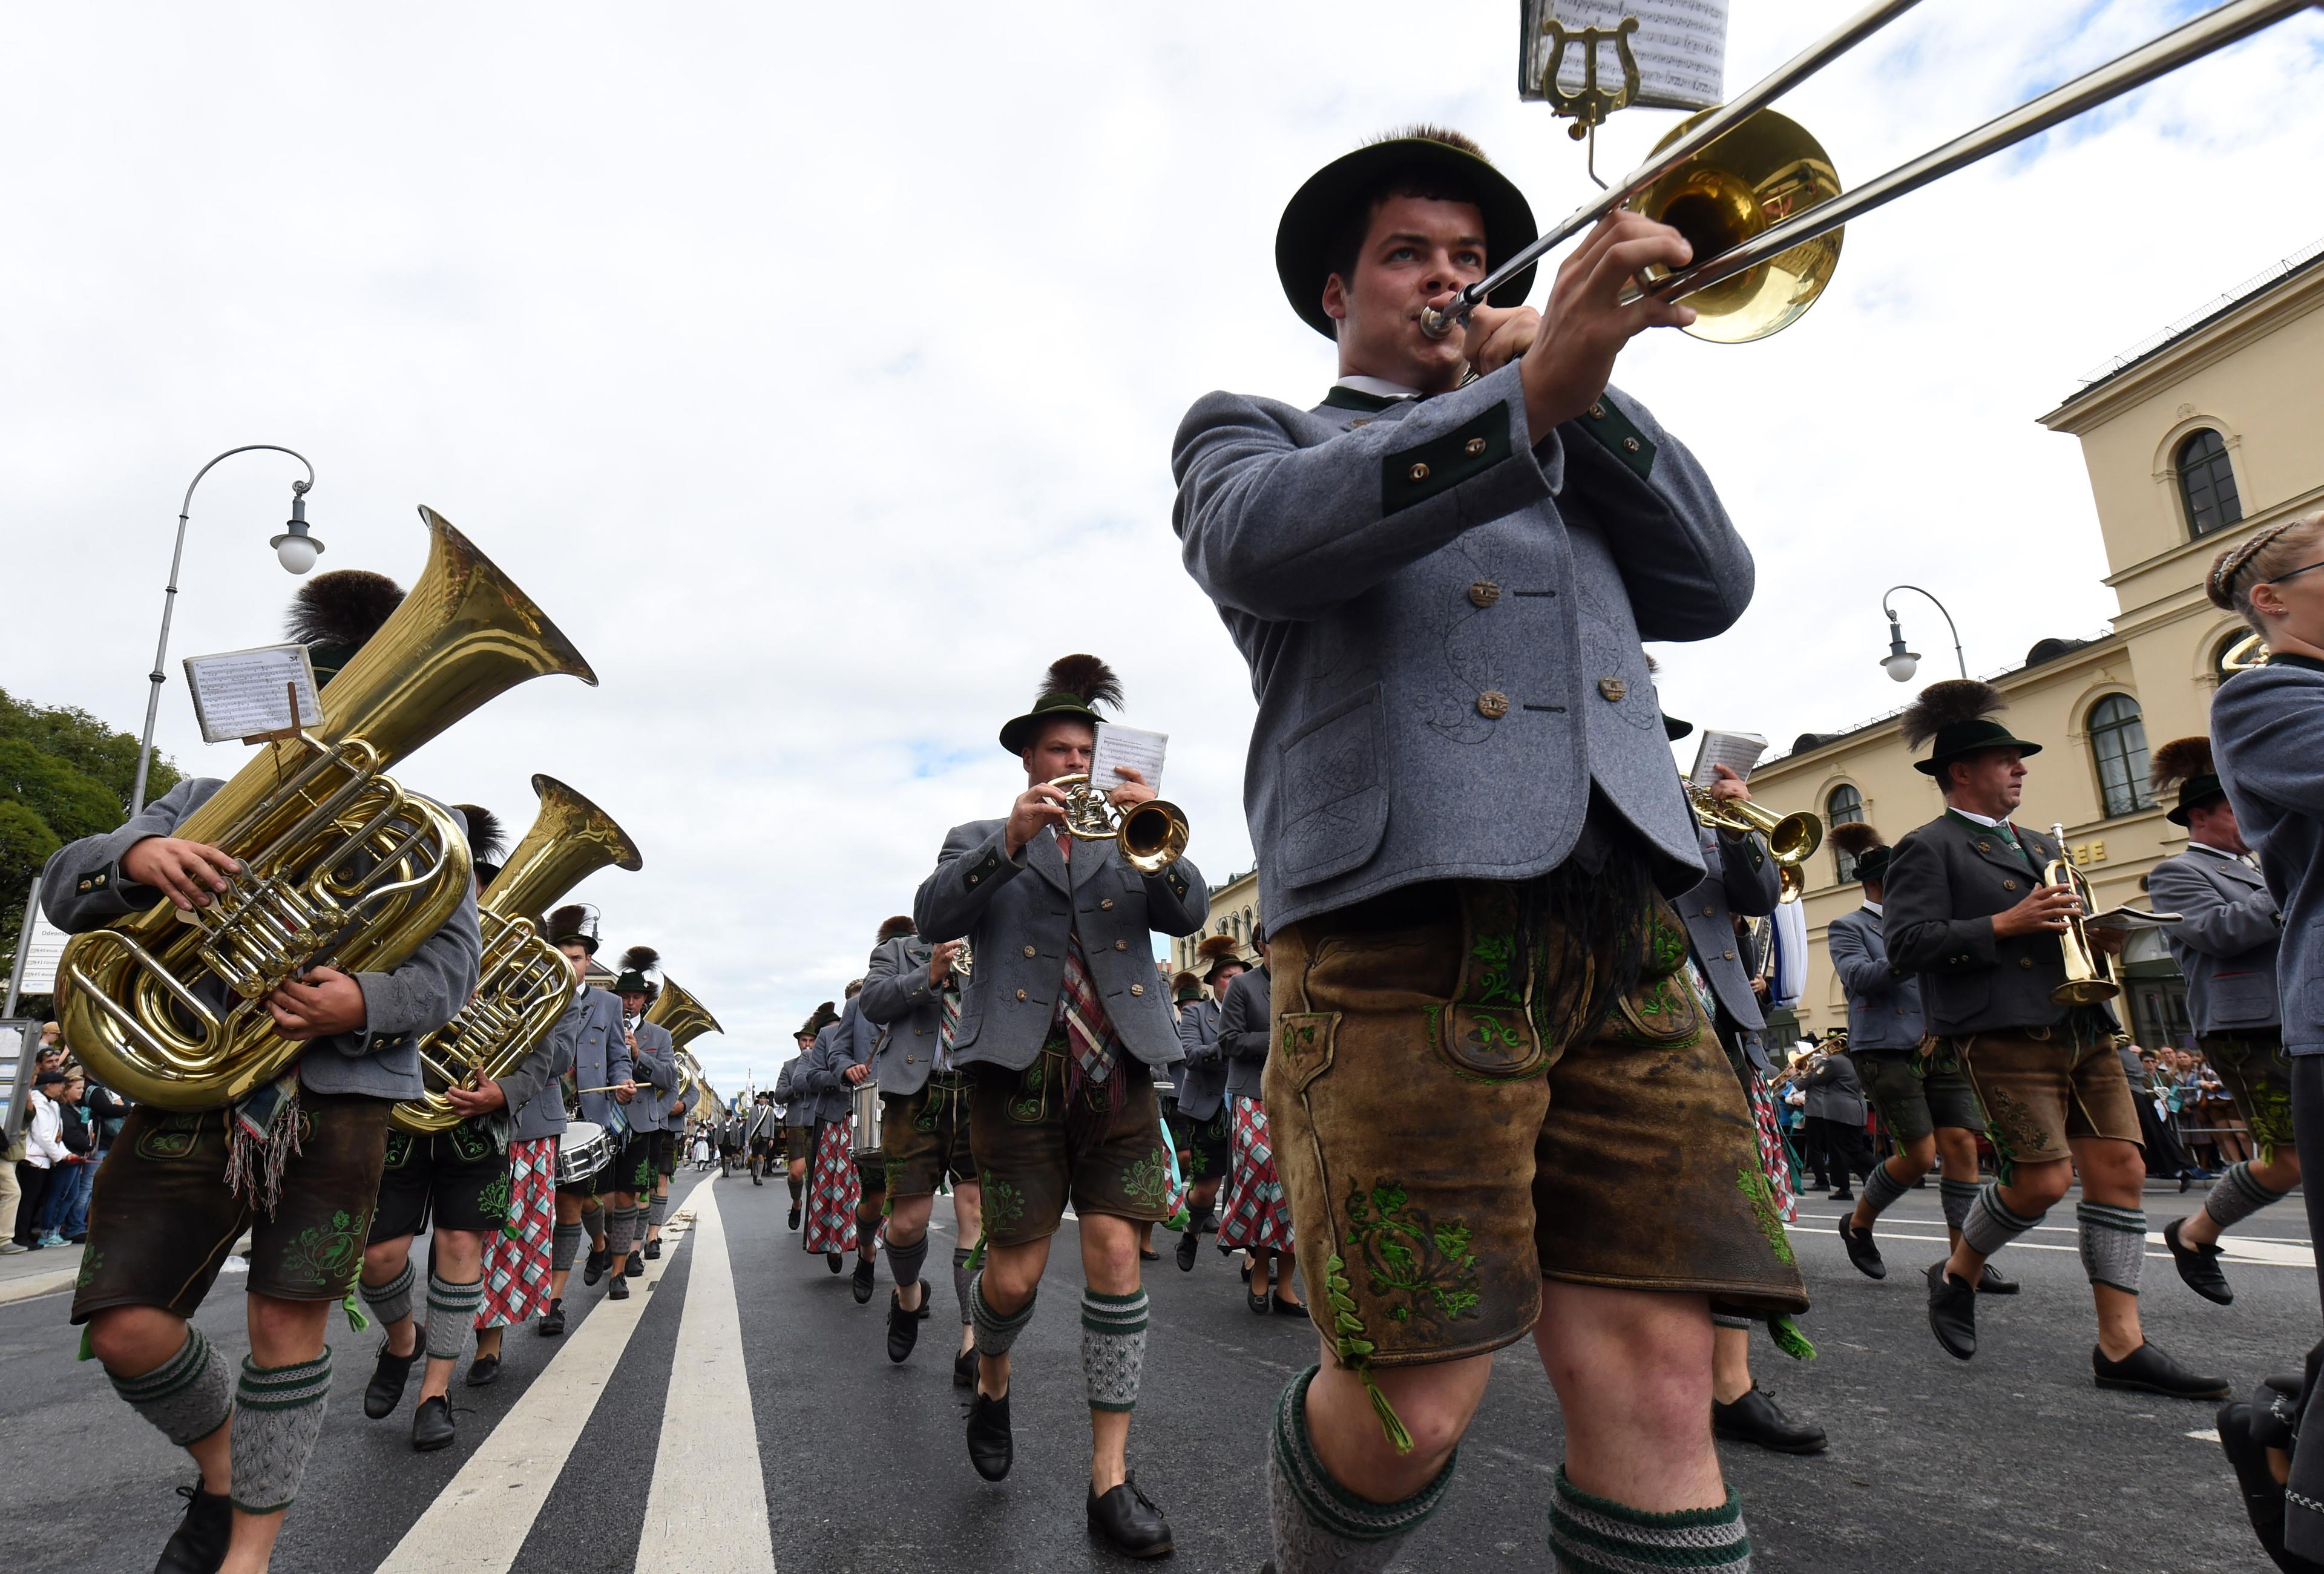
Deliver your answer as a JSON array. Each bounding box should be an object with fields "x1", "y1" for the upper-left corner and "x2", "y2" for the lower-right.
[{"x1": 0, "y1": 1176, "x2": 2317, "y2": 1574}]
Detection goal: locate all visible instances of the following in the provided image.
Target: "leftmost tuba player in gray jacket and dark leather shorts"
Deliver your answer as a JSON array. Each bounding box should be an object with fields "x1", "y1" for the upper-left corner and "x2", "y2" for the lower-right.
[{"x1": 39, "y1": 569, "x2": 484, "y2": 1574}]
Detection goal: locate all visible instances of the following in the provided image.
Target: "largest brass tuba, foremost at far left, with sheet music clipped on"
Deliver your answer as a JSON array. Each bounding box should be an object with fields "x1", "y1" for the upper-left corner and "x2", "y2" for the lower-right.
[{"x1": 56, "y1": 507, "x2": 597, "y2": 1109}]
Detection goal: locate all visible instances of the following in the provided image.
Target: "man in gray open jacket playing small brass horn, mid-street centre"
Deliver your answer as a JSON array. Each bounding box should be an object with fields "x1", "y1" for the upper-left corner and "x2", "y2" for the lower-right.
[{"x1": 913, "y1": 655, "x2": 1209, "y2": 1558}]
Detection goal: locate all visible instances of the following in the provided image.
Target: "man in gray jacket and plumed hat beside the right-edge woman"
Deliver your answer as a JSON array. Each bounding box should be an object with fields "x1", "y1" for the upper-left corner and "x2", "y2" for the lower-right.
[{"x1": 2147, "y1": 735, "x2": 2296, "y2": 1307}]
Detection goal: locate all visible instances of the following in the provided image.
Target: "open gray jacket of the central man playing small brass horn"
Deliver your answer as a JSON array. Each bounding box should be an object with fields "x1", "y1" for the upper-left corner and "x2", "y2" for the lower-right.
[{"x1": 911, "y1": 818, "x2": 1211, "y2": 1072}]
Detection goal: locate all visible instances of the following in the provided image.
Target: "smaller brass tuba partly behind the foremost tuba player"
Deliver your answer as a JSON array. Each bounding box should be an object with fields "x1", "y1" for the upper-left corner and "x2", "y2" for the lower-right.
[{"x1": 388, "y1": 776, "x2": 644, "y2": 1135}]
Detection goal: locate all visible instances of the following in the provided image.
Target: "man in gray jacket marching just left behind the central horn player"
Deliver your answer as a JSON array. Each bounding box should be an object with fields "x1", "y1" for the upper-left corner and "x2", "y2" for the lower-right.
[{"x1": 860, "y1": 916, "x2": 983, "y2": 1388}]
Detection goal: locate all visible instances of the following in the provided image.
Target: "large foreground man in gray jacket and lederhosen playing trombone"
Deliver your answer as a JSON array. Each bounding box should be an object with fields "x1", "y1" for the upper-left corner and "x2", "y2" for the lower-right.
[{"x1": 1180, "y1": 128, "x2": 1804, "y2": 1574}]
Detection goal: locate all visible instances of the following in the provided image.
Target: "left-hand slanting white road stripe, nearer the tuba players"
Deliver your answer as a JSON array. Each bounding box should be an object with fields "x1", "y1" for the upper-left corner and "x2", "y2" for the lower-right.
[{"x1": 379, "y1": 1230, "x2": 678, "y2": 1574}]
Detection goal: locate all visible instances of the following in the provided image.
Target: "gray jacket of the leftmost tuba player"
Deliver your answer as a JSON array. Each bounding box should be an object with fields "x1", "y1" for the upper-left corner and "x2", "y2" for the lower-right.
[{"x1": 39, "y1": 776, "x2": 484, "y2": 1100}]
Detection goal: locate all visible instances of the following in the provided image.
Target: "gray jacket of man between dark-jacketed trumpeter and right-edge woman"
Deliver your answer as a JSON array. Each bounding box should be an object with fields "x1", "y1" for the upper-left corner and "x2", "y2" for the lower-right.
[{"x1": 2147, "y1": 855, "x2": 2277, "y2": 1032}]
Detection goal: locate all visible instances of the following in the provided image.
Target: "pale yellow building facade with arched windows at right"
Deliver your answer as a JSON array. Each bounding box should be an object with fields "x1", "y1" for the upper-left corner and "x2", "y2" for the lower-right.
[{"x1": 1750, "y1": 249, "x2": 2324, "y2": 1044}]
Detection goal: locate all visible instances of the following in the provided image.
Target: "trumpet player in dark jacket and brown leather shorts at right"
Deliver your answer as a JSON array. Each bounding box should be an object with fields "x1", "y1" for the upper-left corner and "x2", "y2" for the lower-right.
[{"x1": 1882, "y1": 679, "x2": 2227, "y2": 1400}]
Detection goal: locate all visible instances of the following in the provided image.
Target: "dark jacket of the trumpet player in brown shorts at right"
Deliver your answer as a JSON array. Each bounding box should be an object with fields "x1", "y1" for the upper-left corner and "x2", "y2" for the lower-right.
[{"x1": 1880, "y1": 809, "x2": 2103, "y2": 1035}]
